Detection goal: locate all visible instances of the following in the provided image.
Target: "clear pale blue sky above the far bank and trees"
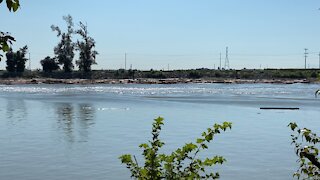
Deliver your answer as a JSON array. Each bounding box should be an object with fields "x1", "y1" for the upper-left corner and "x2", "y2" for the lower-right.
[{"x1": 0, "y1": 0, "x2": 320, "y2": 70}]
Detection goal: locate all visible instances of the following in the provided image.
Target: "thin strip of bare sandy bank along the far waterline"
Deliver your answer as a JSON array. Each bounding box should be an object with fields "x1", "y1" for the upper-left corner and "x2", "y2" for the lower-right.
[{"x1": 0, "y1": 78, "x2": 318, "y2": 85}]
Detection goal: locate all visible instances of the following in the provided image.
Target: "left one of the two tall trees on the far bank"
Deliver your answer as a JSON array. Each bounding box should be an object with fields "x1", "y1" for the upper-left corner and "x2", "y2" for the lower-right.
[{"x1": 51, "y1": 15, "x2": 75, "y2": 72}]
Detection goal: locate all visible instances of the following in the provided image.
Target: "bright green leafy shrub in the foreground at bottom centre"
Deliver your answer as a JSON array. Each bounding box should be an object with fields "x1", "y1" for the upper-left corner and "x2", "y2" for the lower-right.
[{"x1": 119, "y1": 117, "x2": 231, "y2": 180}]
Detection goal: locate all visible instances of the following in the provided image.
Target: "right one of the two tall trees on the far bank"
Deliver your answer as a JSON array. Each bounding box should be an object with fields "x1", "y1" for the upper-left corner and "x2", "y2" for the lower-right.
[{"x1": 76, "y1": 22, "x2": 98, "y2": 72}]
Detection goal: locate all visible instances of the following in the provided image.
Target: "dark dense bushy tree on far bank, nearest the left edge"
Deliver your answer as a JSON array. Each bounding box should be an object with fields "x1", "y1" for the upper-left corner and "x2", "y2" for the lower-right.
[{"x1": 6, "y1": 46, "x2": 28, "y2": 72}]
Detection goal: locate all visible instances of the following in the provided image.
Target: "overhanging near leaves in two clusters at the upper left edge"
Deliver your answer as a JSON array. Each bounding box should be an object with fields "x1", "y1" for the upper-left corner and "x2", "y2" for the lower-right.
[{"x1": 0, "y1": 0, "x2": 20, "y2": 60}]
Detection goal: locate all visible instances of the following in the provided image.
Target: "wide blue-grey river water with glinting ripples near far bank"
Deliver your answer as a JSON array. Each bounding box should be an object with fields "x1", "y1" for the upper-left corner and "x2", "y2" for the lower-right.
[{"x1": 0, "y1": 84, "x2": 320, "y2": 180}]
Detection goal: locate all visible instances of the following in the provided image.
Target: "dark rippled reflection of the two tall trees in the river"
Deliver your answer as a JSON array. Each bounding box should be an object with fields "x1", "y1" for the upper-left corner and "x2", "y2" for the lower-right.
[{"x1": 56, "y1": 103, "x2": 95, "y2": 143}]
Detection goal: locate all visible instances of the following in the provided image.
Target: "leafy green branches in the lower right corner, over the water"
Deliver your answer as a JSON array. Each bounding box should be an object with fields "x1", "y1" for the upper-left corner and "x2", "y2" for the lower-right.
[{"x1": 288, "y1": 123, "x2": 320, "y2": 179}]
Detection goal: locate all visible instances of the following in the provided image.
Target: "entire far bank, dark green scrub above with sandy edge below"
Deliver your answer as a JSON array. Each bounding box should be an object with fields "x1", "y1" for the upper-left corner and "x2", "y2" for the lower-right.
[{"x1": 0, "y1": 68, "x2": 320, "y2": 85}]
